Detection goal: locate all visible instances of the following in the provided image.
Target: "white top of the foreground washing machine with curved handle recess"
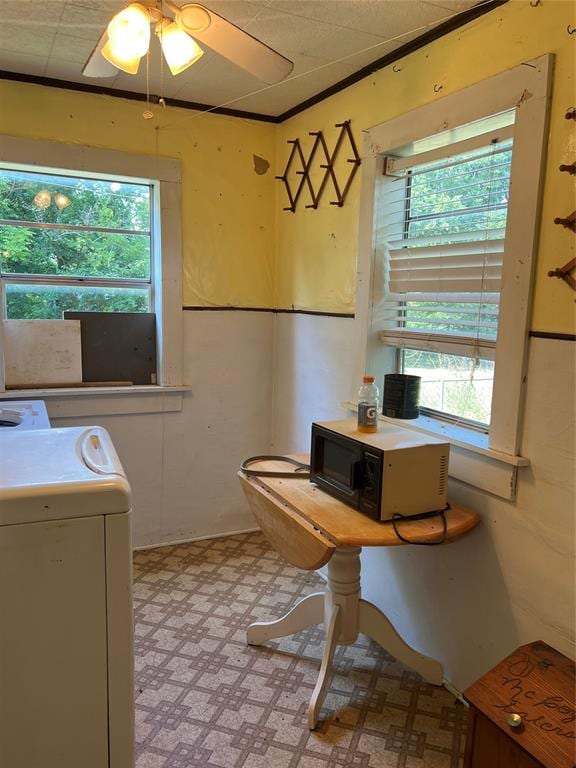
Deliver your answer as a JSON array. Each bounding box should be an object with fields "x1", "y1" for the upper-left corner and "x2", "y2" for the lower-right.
[{"x1": 0, "y1": 427, "x2": 130, "y2": 526}]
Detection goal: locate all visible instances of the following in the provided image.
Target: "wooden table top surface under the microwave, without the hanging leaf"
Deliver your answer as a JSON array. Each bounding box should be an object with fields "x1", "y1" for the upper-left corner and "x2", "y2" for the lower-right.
[{"x1": 240, "y1": 454, "x2": 480, "y2": 547}]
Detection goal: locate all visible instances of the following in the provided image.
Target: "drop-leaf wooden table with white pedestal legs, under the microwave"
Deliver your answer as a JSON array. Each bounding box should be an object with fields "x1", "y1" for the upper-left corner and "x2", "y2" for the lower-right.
[{"x1": 238, "y1": 455, "x2": 480, "y2": 729}]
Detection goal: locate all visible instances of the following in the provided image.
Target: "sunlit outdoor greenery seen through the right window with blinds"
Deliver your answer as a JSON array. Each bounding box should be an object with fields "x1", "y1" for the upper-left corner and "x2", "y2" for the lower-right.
[{"x1": 394, "y1": 145, "x2": 512, "y2": 424}]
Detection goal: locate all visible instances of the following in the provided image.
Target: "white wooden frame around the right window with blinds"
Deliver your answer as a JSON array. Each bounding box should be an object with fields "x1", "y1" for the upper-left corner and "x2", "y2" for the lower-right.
[{"x1": 356, "y1": 54, "x2": 553, "y2": 466}]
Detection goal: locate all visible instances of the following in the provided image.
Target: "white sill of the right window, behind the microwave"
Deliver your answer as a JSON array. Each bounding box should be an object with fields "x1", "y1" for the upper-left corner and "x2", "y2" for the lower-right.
[{"x1": 343, "y1": 401, "x2": 530, "y2": 500}]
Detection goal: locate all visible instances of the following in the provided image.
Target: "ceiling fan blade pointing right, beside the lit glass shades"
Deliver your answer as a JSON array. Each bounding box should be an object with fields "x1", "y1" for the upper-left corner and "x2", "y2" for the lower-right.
[{"x1": 174, "y1": 3, "x2": 294, "y2": 85}]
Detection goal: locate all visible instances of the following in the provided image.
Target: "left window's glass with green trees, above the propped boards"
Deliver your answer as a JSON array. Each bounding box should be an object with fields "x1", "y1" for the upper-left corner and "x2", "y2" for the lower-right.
[{"x1": 0, "y1": 168, "x2": 154, "y2": 319}]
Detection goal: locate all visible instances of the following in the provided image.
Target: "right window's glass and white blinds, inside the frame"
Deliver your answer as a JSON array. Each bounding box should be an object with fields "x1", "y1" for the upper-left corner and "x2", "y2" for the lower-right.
[{"x1": 375, "y1": 113, "x2": 514, "y2": 429}]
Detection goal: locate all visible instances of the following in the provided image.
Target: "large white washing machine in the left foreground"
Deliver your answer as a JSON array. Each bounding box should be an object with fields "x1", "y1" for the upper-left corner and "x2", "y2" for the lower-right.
[{"x1": 0, "y1": 427, "x2": 134, "y2": 768}]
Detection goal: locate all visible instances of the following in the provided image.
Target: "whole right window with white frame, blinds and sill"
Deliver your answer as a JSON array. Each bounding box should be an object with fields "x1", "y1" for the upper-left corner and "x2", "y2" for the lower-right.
[{"x1": 355, "y1": 54, "x2": 553, "y2": 474}]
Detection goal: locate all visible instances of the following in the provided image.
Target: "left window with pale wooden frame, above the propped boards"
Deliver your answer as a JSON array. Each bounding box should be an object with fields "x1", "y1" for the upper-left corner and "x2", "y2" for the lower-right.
[{"x1": 0, "y1": 134, "x2": 182, "y2": 390}]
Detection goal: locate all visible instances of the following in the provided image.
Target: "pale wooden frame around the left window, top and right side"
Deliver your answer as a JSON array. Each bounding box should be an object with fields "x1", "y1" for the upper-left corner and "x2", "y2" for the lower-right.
[{"x1": 0, "y1": 135, "x2": 182, "y2": 394}]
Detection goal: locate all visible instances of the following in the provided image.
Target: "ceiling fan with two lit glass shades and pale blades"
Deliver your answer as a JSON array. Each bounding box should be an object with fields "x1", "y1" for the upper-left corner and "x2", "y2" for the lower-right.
[{"x1": 82, "y1": 0, "x2": 294, "y2": 85}]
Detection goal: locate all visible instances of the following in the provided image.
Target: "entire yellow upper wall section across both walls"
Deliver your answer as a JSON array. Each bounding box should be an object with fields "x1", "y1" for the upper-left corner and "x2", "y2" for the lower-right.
[{"x1": 0, "y1": 0, "x2": 576, "y2": 332}]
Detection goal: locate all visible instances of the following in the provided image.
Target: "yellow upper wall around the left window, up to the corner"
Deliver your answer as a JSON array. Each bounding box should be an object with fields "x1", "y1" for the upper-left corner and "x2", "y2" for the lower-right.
[{"x1": 0, "y1": 81, "x2": 276, "y2": 307}]
